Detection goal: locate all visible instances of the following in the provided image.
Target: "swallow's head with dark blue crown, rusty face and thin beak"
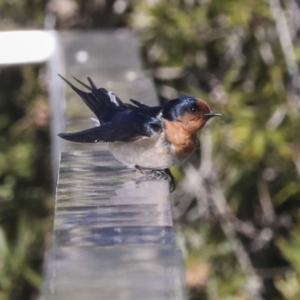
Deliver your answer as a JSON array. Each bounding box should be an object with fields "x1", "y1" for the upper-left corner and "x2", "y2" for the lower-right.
[{"x1": 162, "y1": 96, "x2": 221, "y2": 132}]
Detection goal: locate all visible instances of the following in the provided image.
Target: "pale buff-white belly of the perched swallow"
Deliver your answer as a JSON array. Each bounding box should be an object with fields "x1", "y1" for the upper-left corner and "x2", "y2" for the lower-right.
[{"x1": 109, "y1": 135, "x2": 193, "y2": 170}]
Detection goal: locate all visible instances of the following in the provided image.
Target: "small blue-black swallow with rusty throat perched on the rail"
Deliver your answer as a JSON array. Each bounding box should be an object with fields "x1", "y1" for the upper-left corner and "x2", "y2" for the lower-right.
[{"x1": 58, "y1": 75, "x2": 221, "y2": 191}]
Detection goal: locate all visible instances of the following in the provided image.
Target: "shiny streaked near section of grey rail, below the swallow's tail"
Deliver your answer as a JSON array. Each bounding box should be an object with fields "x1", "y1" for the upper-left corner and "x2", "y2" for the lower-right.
[{"x1": 43, "y1": 150, "x2": 185, "y2": 300}]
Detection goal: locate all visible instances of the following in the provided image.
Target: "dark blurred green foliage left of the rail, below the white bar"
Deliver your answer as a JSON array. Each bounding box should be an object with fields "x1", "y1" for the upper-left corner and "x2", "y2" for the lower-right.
[{"x1": 0, "y1": 66, "x2": 53, "y2": 299}]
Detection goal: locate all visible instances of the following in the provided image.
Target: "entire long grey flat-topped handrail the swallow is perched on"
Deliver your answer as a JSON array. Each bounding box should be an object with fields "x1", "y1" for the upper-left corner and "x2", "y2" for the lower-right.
[{"x1": 41, "y1": 31, "x2": 185, "y2": 300}]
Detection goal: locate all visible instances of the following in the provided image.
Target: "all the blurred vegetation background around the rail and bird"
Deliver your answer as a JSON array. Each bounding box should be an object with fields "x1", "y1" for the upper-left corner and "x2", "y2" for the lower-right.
[{"x1": 0, "y1": 0, "x2": 300, "y2": 300}]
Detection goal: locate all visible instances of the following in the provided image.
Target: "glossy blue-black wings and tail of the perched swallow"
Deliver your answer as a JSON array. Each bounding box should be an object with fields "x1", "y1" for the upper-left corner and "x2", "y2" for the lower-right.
[{"x1": 59, "y1": 75, "x2": 162, "y2": 143}]
